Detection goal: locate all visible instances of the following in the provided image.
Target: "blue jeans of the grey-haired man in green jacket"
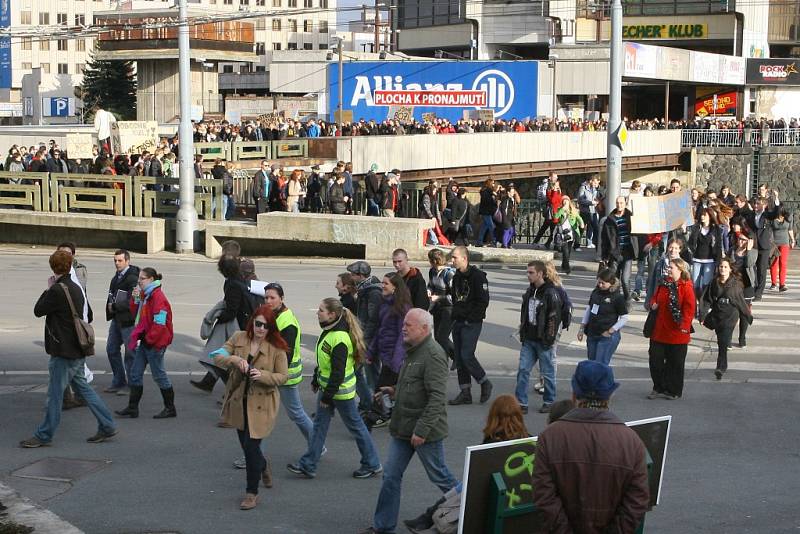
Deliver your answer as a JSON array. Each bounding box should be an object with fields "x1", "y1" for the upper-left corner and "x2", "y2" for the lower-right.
[{"x1": 373, "y1": 438, "x2": 458, "y2": 532}]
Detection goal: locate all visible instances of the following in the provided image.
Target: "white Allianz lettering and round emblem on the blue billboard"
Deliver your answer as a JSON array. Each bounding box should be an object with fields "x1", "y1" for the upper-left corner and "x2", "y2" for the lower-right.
[{"x1": 350, "y1": 69, "x2": 515, "y2": 117}]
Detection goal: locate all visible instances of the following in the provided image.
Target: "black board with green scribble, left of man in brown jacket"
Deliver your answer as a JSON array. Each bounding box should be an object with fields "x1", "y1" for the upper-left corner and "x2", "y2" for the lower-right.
[{"x1": 458, "y1": 438, "x2": 539, "y2": 534}]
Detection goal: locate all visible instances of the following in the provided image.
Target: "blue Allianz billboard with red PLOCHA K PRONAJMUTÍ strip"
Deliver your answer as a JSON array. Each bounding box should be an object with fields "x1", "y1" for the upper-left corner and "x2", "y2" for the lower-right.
[{"x1": 328, "y1": 61, "x2": 538, "y2": 122}]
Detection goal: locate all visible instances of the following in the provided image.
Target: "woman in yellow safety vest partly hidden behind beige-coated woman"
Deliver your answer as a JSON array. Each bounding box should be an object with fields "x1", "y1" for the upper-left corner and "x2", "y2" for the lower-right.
[{"x1": 233, "y1": 282, "x2": 316, "y2": 469}]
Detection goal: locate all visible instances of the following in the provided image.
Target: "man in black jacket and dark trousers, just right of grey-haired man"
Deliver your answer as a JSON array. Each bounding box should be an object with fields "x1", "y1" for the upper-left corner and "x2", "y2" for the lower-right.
[{"x1": 449, "y1": 247, "x2": 492, "y2": 406}]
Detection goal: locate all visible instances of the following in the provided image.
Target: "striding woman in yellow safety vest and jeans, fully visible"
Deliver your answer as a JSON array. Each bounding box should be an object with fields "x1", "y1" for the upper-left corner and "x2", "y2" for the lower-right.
[{"x1": 286, "y1": 298, "x2": 383, "y2": 478}]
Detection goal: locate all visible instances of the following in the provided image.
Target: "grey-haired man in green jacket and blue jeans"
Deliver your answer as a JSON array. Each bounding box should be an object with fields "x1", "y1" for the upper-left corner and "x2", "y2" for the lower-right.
[{"x1": 362, "y1": 308, "x2": 458, "y2": 534}]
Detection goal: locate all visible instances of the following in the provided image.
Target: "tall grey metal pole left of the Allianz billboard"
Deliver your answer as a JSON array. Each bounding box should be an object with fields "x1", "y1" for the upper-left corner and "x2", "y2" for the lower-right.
[{"x1": 175, "y1": 0, "x2": 198, "y2": 254}]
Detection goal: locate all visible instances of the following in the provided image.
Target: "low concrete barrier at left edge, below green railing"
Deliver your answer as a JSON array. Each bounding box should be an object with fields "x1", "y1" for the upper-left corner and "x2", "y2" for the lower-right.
[{"x1": 0, "y1": 209, "x2": 165, "y2": 254}]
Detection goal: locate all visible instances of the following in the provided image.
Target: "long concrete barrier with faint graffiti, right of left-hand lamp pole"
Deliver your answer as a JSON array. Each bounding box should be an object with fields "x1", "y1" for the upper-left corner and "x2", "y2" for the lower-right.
[{"x1": 205, "y1": 212, "x2": 433, "y2": 260}]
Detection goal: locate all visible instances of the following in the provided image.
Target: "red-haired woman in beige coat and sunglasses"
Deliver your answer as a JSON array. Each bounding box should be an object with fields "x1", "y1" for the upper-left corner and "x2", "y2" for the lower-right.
[{"x1": 209, "y1": 305, "x2": 289, "y2": 510}]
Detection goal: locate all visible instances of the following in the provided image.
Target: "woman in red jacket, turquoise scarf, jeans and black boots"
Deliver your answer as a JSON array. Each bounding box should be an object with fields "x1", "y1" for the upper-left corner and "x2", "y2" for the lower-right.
[{"x1": 115, "y1": 267, "x2": 178, "y2": 419}]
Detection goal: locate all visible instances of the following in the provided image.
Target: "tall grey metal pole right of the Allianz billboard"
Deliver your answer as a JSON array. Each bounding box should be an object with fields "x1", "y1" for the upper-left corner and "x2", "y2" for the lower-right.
[{"x1": 606, "y1": 0, "x2": 623, "y2": 213}]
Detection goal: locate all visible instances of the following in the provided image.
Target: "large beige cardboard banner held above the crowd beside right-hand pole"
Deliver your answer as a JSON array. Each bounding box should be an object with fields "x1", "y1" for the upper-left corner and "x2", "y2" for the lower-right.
[{"x1": 629, "y1": 190, "x2": 694, "y2": 234}]
